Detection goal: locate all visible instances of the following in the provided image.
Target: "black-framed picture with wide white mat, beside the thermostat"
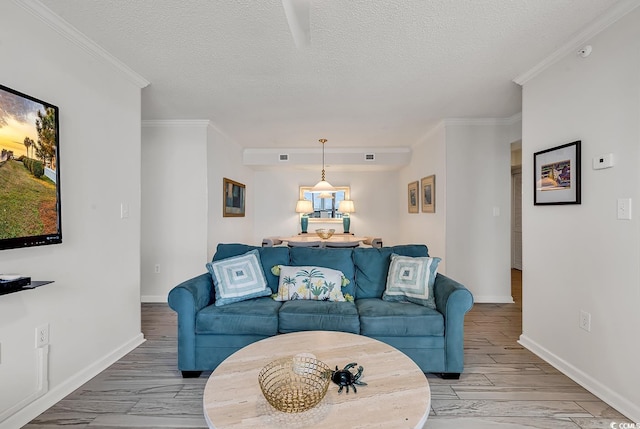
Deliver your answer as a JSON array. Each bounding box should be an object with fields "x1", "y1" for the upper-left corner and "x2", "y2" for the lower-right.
[{"x1": 533, "y1": 140, "x2": 581, "y2": 205}]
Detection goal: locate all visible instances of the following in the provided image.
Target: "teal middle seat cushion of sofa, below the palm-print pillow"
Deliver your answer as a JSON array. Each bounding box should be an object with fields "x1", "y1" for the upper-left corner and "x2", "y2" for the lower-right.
[{"x1": 278, "y1": 300, "x2": 360, "y2": 334}]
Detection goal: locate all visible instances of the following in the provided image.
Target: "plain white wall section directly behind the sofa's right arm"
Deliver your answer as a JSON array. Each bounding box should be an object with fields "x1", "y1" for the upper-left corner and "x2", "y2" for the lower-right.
[{"x1": 446, "y1": 120, "x2": 513, "y2": 302}]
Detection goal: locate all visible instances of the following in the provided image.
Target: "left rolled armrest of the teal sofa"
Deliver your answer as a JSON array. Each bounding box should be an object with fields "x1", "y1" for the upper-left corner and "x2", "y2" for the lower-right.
[{"x1": 168, "y1": 273, "x2": 213, "y2": 371}]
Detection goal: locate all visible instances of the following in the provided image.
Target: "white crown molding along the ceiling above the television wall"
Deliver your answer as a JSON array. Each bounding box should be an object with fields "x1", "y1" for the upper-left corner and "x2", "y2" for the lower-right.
[{"x1": 13, "y1": 0, "x2": 150, "y2": 88}]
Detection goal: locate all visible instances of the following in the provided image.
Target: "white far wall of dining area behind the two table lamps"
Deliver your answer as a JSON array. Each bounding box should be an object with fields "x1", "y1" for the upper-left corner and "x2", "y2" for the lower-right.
[{"x1": 252, "y1": 169, "x2": 400, "y2": 245}]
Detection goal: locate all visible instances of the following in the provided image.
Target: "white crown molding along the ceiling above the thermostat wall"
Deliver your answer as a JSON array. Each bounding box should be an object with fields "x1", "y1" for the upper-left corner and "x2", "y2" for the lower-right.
[{"x1": 513, "y1": 0, "x2": 640, "y2": 85}]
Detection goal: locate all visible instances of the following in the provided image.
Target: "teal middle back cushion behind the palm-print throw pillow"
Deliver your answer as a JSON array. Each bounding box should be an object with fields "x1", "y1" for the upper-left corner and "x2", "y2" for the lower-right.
[{"x1": 284, "y1": 247, "x2": 355, "y2": 297}]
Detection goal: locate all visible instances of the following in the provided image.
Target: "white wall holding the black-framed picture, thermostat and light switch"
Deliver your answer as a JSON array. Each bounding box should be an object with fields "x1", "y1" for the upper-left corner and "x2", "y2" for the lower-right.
[{"x1": 521, "y1": 9, "x2": 640, "y2": 422}]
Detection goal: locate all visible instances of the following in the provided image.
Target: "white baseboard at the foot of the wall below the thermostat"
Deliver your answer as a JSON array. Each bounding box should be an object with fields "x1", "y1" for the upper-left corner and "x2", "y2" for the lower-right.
[{"x1": 518, "y1": 334, "x2": 640, "y2": 422}]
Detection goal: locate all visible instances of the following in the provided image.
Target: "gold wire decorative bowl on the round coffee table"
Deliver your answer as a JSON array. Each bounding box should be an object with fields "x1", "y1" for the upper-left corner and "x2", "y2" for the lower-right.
[{"x1": 258, "y1": 355, "x2": 331, "y2": 413}]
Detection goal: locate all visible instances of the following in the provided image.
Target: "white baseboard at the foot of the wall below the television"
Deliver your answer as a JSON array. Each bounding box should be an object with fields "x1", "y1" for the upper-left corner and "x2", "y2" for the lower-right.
[{"x1": 0, "y1": 333, "x2": 146, "y2": 429}]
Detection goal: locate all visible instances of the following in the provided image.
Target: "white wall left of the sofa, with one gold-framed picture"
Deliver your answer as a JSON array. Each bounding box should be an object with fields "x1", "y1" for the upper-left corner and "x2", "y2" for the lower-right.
[{"x1": 141, "y1": 120, "x2": 255, "y2": 302}]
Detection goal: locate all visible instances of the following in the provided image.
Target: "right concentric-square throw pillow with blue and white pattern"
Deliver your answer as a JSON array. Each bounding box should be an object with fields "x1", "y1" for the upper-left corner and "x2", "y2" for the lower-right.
[{"x1": 382, "y1": 253, "x2": 440, "y2": 308}]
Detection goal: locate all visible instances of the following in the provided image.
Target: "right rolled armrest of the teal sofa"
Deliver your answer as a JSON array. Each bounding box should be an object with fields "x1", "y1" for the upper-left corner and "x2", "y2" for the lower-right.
[{"x1": 433, "y1": 274, "x2": 473, "y2": 373}]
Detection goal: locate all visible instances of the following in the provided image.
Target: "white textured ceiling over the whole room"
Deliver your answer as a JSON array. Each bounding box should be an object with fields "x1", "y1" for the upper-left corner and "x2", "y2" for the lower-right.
[{"x1": 40, "y1": 0, "x2": 616, "y2": 148}]
